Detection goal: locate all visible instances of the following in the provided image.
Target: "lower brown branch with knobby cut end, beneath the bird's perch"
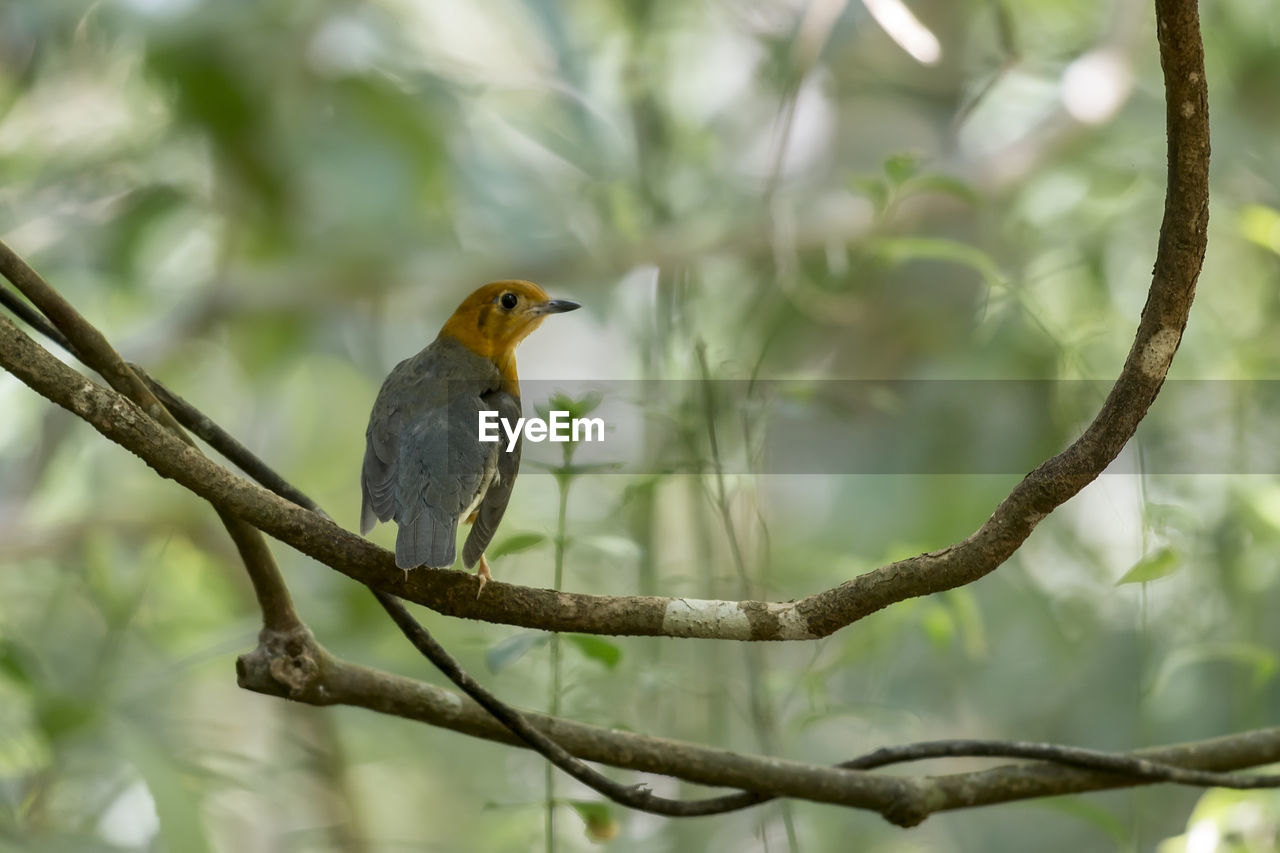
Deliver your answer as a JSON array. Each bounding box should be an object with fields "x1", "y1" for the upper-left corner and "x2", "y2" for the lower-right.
[{"x1": 237, "y1": 617, "x2": 1280, "y2": 826}]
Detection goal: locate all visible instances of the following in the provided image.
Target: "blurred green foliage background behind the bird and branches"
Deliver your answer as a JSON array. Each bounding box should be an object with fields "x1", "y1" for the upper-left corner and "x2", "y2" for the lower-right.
[{"x1": 0, "y1": 0, "x2": 1280, "y2": 853}]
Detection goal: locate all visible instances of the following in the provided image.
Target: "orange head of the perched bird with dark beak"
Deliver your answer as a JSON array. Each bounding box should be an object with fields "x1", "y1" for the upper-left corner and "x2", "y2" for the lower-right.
[{"x1": 440, "y1": 279, "x2": 581, "y2": 383}]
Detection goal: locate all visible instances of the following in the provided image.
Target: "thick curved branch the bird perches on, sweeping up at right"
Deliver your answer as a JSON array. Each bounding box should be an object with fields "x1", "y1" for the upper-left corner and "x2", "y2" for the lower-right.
[{"x1": 0, "y1": 0, "x2": 1210, "y2": 640}]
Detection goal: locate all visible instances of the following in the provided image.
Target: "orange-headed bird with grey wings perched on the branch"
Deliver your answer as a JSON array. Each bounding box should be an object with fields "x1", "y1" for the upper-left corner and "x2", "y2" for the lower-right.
[{"x1": 360, "y1": 279, "x2": 581, "y2": 597}]
